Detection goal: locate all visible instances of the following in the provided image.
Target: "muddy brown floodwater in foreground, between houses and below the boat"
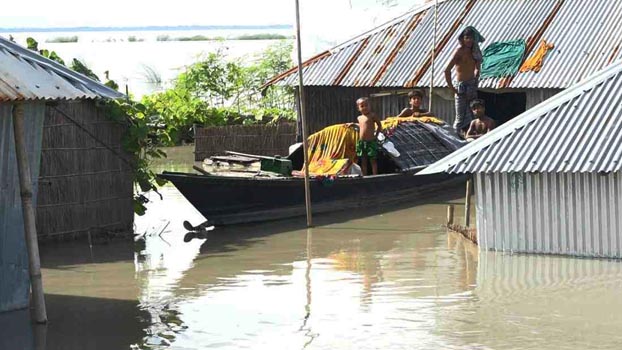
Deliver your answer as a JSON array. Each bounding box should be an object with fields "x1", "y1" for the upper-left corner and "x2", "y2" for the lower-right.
[{"x1": 0, "y1": 149, "x2": 622, "y2": 350}]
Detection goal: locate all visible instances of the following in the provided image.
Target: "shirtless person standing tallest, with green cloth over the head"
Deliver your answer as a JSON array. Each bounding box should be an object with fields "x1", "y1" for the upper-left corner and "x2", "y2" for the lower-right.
[{"x1": 445, "y1": 27, "x2": 484, "y2": 135}]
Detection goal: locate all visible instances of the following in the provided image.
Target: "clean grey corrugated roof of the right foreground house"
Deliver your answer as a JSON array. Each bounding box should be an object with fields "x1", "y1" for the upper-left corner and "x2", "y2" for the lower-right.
[{"x1": 421, "y1": 60, "x2": 622, "y2": 174}]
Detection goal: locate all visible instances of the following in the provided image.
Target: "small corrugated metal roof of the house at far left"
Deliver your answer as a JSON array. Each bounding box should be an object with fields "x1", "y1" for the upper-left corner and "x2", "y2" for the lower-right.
[{"x1": 0, "y1": 37, "x2": 125, "y2": 101}]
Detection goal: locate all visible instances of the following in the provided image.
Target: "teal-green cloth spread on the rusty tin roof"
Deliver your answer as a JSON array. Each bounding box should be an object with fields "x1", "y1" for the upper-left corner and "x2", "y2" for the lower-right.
[{"x1": 480, "y1": 39, "x2": 526, "y2": 79}]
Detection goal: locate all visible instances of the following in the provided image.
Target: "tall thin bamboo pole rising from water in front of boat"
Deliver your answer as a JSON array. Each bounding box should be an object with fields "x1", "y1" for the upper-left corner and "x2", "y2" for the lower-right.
[{"x1": 296, "y1": 0, "x2": 313, "y2": 227}]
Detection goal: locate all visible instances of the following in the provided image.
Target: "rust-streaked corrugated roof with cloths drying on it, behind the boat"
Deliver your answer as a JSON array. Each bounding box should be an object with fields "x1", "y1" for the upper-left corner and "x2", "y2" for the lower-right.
[{"x1": 266, "y1": 0, "x2": 622, "y2": 88}]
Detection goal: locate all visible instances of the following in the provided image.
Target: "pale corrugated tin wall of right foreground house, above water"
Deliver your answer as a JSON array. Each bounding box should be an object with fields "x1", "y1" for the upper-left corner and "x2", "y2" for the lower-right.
[{"x1": 475, "y1": 173, "x2": 622, "y2": 258}]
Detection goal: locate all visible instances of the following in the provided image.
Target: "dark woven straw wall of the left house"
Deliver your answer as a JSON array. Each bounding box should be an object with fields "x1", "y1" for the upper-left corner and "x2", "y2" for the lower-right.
[{"x1": 37, "y1": 101, "x2": 134, "y2": 240}]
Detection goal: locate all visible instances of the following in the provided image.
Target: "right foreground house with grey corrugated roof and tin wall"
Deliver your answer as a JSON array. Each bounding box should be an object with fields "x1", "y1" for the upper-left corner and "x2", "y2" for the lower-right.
[{"x1": 422, "y1": 61, "x2": 622, "y2": 258}]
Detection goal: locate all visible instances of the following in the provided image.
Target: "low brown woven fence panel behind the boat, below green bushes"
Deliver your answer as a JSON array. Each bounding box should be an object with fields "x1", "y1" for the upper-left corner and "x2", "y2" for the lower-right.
[{"x1": 194, "y1": 123, "x2": 296, "y2": 161}]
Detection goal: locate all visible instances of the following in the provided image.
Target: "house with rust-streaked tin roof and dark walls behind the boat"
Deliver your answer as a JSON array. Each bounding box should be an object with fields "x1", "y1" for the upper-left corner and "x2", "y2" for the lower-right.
[{"x1": 266, "y1": 0, "x2": 622, "y2": 133}]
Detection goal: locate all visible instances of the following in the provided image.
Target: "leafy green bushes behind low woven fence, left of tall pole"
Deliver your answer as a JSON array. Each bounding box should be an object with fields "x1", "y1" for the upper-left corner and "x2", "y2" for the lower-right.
[{"x1": 142, "y1": 41, "x2": 295, "y2": 146}]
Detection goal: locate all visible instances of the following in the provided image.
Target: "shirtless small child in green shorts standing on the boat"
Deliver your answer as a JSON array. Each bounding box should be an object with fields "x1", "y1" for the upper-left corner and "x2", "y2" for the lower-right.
[{"x1": 356, "y1": 97, "x2": 382, "y2": 175}]
